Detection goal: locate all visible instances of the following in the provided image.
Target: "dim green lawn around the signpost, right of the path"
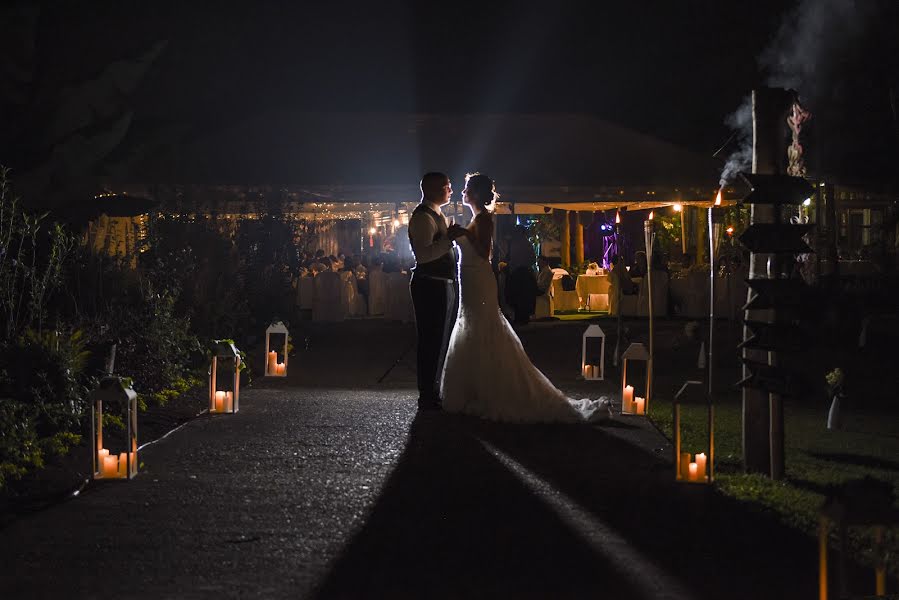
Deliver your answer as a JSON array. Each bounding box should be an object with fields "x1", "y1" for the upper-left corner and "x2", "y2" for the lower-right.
[{"x1": 651, "y1": 398, "x2": 899, "y2": 577}]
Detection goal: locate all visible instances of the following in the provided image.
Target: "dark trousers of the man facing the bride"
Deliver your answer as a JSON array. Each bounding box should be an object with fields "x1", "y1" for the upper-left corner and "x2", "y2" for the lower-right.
[{"x1": 409, "y1": 275, "x2": 456, "y2": 403}]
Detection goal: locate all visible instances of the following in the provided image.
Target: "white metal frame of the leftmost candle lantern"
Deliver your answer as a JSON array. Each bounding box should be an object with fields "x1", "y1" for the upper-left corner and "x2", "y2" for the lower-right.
[{"x1": 91, "y1": 375, "x2": 138, "y2": 481}]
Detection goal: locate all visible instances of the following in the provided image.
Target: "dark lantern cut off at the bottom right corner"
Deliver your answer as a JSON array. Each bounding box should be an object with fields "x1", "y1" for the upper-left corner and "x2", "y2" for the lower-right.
[{"x1": 818, "y1": 477, "x2": 899, "y2": 600}]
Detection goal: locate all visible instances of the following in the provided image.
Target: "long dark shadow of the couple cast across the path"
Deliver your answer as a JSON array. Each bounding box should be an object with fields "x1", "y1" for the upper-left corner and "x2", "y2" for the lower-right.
[{"x1": 317, "y1": 414, "x2": 864, "y2": 599}]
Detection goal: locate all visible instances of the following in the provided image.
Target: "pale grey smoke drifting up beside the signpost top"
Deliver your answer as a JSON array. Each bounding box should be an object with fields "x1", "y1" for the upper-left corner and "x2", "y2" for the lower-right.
[{"x1": 720, "y1": 0, "x2": 876, "y2": 187}]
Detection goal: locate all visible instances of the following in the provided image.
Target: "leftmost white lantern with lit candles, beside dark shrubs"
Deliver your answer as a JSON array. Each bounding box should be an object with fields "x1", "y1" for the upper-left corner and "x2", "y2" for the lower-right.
[{"x1": 91, "y1": 375, "x2": 137, "y2": 480}]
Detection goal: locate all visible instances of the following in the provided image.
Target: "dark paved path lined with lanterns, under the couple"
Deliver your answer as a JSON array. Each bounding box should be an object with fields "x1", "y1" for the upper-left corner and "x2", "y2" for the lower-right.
[{"x1": 0, "y1": 321, "x2": 828, "y2": 599}]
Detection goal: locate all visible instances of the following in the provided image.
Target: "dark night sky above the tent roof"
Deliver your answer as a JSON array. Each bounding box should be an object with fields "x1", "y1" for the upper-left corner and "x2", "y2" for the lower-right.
[{"x1": 1, "y1": 0, "x2": 899, "y2": 183}]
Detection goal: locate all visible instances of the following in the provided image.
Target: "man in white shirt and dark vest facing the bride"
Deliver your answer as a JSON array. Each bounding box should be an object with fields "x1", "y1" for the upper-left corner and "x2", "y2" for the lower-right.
[{"x1": 409, "y1": 173, "x2": 465, "y2": 410}]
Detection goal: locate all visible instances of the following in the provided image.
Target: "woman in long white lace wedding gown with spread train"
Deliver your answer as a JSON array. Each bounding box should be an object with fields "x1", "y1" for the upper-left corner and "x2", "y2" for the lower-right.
[{"x1": 441, "y1": 173, "x2": 611, "y2": 423}]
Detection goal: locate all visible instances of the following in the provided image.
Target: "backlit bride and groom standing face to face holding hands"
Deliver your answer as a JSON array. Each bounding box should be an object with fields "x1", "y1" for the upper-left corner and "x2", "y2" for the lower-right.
[{"x1": 409, "y1": 173, "x2": 611, "y2": 423}]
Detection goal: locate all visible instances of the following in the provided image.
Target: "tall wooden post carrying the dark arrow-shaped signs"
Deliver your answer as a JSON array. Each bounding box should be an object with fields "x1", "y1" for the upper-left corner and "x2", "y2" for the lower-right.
[{"x1": 743, "y1": 88, "x2": 793, "y2": 478}]
